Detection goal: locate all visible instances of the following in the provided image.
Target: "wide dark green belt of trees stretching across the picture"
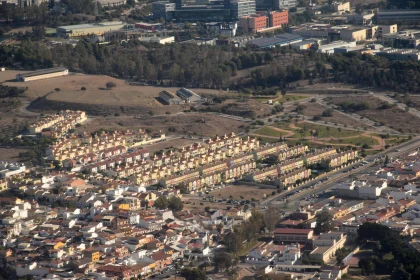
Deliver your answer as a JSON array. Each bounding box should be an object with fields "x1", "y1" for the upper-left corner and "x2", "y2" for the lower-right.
[{"x1": 4, "y1": 40, "x2": 420, "y2": 93}]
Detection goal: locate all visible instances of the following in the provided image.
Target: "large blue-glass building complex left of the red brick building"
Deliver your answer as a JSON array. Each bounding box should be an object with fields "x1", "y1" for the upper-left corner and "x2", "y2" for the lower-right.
[{"x1": 152, "y1": 0, "x2": 256, "y2": 22}]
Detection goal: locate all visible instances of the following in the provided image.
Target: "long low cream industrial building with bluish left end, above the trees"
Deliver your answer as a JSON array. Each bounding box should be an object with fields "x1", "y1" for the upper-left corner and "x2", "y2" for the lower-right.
[{"x1": 57, "y1": 21, "x2": 125, "y2": 38}]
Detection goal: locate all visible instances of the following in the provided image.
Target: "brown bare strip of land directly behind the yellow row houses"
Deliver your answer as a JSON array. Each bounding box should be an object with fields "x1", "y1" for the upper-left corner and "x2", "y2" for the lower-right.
[{"x1": 81, "y1": 113, "x2": 244, "y2": 137}]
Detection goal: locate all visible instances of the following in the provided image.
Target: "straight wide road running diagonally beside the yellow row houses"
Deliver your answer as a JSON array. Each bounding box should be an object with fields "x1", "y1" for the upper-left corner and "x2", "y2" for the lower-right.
[{"x1": 260, "y1": 138, "x2": 420, "y2": 207}]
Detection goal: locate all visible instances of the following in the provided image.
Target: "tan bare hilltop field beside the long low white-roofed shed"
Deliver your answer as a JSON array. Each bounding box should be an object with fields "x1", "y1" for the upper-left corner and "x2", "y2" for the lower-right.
[{"x1": 0, "y1": 71, "x2": 230, "y2": 103}]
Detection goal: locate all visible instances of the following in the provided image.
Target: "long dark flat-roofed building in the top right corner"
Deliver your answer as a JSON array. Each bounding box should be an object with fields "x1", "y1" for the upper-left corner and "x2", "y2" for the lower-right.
[{"x1": 376, "y1": 9, "x2": 420, "y2": 25}]
